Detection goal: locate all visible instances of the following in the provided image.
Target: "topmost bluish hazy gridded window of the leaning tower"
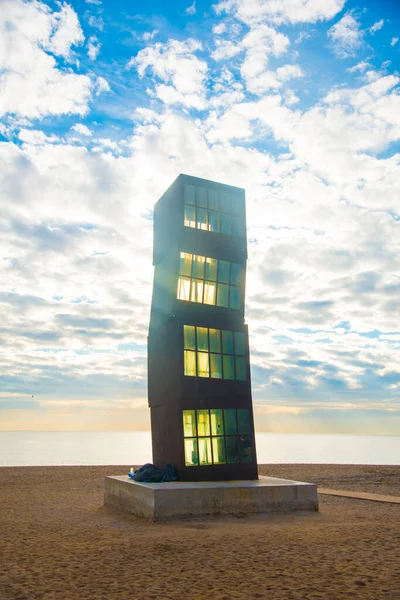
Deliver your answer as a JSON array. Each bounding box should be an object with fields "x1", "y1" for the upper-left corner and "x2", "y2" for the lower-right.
[{"x1": 183, "y1": 184, "x2": 245, "y2": 237}]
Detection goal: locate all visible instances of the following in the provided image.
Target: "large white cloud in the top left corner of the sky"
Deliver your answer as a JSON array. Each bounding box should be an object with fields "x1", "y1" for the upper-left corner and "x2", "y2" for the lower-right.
[{"x1": 0, "y1": 0, "x2": 93, "y2": 118}]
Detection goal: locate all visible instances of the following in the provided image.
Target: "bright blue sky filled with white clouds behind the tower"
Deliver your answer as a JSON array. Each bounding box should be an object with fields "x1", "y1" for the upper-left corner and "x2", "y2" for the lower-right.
[{"x1": 0, "y1": 0, "x2": 400, "y2": 435}]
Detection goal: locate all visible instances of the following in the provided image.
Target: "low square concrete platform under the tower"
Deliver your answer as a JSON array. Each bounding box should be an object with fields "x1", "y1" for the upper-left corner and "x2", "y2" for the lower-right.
[{"x1": 104, "y1": 475, "x2": 318, "y2": 521}]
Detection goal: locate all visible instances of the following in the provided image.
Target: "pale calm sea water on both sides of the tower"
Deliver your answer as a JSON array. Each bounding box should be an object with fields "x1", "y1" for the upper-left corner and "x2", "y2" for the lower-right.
[{"x1": 0, "y1": 431, "x2": 400, "y2": 467}]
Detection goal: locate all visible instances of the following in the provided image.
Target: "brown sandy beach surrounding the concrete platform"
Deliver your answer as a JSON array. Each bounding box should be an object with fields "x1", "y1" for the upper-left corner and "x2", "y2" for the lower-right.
[{"x1": 0, "y1": 465, "x2": 400, "y2": 600}]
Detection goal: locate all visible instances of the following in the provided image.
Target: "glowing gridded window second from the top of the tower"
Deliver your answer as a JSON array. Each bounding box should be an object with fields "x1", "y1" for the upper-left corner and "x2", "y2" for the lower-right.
[{"x1": 177, "y1": 252, "x2": 243, "y2": 309}]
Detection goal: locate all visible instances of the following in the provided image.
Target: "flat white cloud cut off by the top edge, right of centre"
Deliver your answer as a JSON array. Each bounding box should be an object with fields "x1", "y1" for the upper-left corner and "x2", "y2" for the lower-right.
[{"x1": 214, "y1": 0, "x2": 346, "y2": 25}]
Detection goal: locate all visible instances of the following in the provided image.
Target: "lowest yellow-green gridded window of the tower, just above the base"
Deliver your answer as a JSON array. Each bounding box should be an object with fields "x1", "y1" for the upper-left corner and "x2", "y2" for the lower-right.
[{"x1": 182, "y1": 408, "x2": 252, "y2": 467}]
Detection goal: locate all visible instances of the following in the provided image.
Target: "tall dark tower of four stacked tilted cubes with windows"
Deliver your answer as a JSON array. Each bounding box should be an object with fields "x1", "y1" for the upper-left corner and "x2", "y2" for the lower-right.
[{"x1": 148, "y1": 175, "x2": 258, "y2": 481}]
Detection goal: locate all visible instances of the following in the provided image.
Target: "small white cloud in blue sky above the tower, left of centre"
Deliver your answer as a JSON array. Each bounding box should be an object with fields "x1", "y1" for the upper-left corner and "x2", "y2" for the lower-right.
[{"x1": 128, "y1": 39, "x2": 208, "y2": 109}]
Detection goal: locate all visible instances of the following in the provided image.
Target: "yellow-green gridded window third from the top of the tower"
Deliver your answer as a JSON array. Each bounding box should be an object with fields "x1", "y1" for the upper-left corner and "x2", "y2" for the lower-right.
[{"x1": 183, "y1": 325, "x2": 247, "y2": 381}]
